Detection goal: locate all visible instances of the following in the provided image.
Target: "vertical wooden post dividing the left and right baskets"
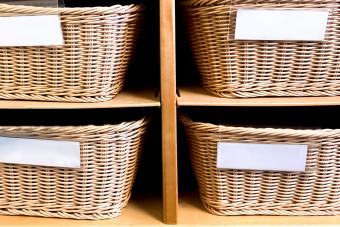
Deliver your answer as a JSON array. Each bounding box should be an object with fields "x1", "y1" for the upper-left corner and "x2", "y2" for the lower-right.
[{"x1": 160, "y1": 0, "x2": 178, "y2": 224}]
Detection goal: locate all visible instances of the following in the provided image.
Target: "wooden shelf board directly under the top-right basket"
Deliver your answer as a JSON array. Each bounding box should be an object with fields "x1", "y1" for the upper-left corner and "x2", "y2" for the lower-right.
[{"x1": 177, "y1": 87, "x2": 340, "y2": 107}]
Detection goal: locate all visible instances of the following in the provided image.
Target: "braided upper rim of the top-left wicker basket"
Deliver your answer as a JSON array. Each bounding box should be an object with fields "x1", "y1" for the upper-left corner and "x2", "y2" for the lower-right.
[{"x1": 0, "y1": 3, "x2": 144, "y2": 14}]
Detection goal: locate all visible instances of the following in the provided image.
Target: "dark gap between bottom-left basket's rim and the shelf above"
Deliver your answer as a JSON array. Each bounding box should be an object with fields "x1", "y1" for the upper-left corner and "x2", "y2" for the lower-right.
[{"x1": 0, "y1": 108, "x2": 157, "y2": 126}]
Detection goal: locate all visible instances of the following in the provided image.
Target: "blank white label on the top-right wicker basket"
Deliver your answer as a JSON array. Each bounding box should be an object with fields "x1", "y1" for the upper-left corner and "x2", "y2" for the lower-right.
[{"x1": 235, "y1": 9, "x2": 329, "y2": 41}]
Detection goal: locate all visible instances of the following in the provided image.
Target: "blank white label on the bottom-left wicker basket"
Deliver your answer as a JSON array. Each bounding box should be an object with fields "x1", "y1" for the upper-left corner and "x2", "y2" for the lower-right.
[{"x1": 0, "y1": 137, "x2": 80, "y2": 168}]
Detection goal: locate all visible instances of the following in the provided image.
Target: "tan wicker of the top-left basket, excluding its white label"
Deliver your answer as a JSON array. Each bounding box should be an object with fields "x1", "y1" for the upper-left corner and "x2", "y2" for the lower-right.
[{"x1": 0, "y1": 4, "x2": 143, "y2": 102}]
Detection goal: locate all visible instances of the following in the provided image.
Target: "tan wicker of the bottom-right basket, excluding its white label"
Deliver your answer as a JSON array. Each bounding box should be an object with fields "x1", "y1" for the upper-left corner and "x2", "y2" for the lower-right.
[{"x1": 181, "y1": 116, "x2": 340, "y2": 215}]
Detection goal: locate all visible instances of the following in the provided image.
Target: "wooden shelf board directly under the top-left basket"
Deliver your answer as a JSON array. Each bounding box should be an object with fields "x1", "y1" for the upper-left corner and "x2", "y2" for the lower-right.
[{"x1": 0, "y1": 89, "x2": 160, "y2": 109}]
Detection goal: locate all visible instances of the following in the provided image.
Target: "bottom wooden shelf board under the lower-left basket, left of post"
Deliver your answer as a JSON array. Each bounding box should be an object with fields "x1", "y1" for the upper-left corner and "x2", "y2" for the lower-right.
[{"x1": 0, "y1": 198, "x2": 162, "y2": 226}]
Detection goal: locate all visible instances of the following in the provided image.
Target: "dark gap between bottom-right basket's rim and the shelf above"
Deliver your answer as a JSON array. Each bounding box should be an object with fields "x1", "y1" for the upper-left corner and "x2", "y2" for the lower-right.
[{"x1": 181, "y1": 106, "x2": 340, "y2": 129}]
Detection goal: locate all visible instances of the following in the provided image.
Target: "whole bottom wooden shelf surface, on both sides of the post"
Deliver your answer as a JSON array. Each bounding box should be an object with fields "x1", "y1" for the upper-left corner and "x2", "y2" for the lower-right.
[{"x1": 0, "y1": 194, "x2": 340, "y2": 227}]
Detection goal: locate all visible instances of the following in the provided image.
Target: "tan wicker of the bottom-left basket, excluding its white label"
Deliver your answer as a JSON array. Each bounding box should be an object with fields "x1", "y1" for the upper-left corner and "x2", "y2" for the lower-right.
[{"x1": 0, "y1": 116, "x2": 148, "y2": 219}]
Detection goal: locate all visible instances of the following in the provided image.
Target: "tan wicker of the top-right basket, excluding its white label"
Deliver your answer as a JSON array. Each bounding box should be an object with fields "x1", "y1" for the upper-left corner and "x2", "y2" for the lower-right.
[{"x1": 183, "y1": 0, "x2": 340, "y2": 97}]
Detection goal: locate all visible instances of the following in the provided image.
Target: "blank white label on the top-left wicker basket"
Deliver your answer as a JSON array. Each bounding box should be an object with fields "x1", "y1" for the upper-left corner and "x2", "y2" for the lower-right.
[{"x1": 0, "y1": 15, "x2": 64, "y2": 47}]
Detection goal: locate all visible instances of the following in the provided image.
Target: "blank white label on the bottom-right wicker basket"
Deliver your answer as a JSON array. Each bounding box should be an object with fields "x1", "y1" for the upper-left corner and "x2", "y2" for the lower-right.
[{"x1": 217, "y1": 142, "x2": 308, "y2": 172}]
